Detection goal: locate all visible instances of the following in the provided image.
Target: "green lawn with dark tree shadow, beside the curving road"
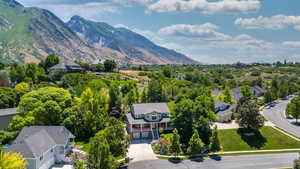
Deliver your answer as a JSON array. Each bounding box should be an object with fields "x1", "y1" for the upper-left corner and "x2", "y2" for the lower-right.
[{"x1": 219, "y1": 127, "x2": 300, "y2": 151}]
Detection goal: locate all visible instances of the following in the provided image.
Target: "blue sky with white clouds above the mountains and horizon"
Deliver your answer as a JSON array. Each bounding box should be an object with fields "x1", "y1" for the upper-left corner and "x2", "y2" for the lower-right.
[{"x1": 20, "y1": 0, "x2": 300, "y2": 63}]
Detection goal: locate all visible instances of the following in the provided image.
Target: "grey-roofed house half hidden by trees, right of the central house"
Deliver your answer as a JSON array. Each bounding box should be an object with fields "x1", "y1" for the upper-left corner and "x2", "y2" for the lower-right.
[{"x1": 214, "y1": 99, "x2": 234, "y2": 122}]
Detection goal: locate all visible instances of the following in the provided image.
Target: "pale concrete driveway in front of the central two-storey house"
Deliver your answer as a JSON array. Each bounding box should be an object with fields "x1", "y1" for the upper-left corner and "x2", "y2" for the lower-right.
[{"x1": 127, "y1": 140, "x2": 157, "y2": 162}]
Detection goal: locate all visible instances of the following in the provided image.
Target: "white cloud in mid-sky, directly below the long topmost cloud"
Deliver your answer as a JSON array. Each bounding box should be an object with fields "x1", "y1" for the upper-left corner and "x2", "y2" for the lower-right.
[{"x1": 159, "y1": 23, "x2": 230, "y2": 40}]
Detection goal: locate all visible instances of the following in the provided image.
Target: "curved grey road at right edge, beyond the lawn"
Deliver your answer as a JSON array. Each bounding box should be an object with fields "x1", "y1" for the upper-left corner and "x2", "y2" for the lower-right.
[{"x1": 263, "y1": 99, "x2": 300, "y2": 137}]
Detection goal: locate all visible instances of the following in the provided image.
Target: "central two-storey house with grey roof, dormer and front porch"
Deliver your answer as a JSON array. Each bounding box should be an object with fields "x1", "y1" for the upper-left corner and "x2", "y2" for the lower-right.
[{"x1": 126, "y1": 103, "x2": 172, "y2": 140}]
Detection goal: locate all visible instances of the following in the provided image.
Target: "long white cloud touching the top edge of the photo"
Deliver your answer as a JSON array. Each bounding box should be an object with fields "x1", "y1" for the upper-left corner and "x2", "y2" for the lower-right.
[{"x1": 148, "y1": 0, "x2": 261, "y2": 14}]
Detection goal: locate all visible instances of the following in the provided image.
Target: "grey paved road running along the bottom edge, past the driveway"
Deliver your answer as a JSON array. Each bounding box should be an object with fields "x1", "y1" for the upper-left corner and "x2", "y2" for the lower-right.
[{"x1": 128, "y1": 153, "x2": 298, "y2": 169}]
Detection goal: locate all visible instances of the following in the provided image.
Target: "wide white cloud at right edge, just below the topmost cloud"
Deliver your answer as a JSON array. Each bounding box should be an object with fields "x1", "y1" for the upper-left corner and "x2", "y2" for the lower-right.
[{"x1": 235, "y1": 14, "x2": 300, "y2": 30}]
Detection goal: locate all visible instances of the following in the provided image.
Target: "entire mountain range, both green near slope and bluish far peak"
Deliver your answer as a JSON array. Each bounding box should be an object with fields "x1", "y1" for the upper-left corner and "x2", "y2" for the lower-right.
[{"x1": 0, "y1": 0, "x2": 197, "y2": 64}]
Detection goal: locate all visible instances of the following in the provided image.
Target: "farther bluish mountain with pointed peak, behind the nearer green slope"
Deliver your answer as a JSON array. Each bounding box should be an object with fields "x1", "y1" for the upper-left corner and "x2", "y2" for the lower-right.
[{"x1": 67, "y1": 16, "x2": 196, "y2": 64}]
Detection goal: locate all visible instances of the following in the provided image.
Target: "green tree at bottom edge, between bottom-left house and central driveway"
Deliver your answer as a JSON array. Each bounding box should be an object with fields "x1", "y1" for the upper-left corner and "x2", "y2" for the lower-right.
[{"x1": 88, "y1": 134, "x2": 116, "y2": 169}]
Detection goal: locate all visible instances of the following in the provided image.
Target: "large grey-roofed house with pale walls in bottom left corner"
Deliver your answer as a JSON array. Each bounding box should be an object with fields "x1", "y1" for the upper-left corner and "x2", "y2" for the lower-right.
[{"x1": 4, "y1": 126, "x2": 75, "y2": 169}]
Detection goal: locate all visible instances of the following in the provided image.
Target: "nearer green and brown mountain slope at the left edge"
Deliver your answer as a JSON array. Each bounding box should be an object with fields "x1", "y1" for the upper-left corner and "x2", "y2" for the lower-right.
[{"x1": 0, "y1": 0, "x2": 128, "y2": 63}]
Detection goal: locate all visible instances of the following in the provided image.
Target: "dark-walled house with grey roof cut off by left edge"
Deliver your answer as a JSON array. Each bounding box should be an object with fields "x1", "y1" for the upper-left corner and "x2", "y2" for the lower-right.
[{"x1": 0, "y1": 108, "x2": 19, "y2": 130}]
